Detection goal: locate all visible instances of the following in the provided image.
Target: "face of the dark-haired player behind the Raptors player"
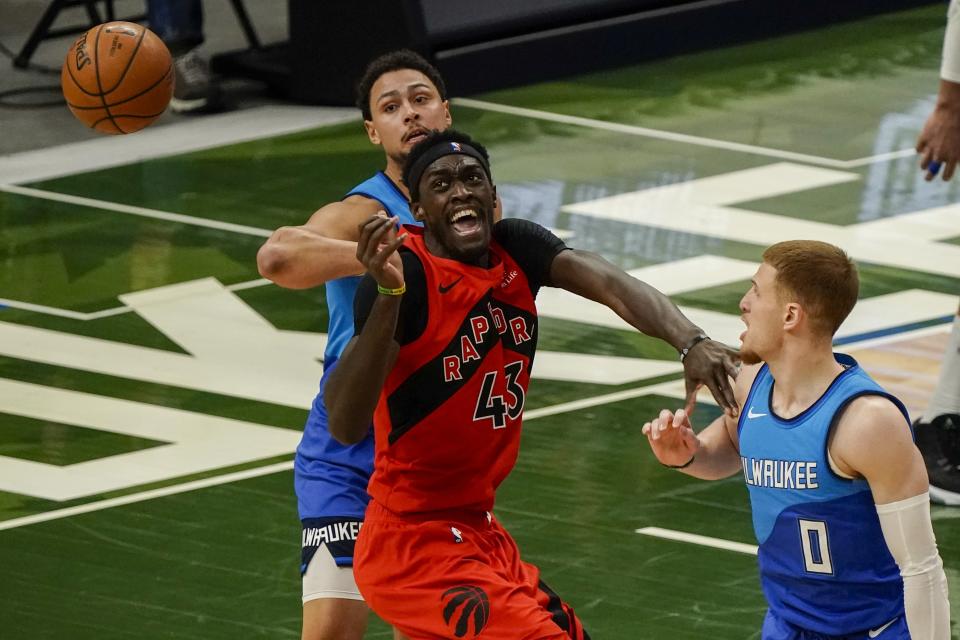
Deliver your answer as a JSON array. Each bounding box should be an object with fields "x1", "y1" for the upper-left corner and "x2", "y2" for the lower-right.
[{"x1": 364, "y1": 69, "x2": 451, "y2": 164}]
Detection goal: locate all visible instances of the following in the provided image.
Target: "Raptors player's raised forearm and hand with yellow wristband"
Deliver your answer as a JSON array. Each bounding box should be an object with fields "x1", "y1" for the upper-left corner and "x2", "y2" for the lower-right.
[{"x1": 324, "y1": 216, "x2": 406, "y2": 444}]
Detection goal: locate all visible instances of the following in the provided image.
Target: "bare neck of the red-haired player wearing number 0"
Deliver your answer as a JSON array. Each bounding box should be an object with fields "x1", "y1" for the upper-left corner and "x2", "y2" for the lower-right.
[{"x1": 767, "y1": 341, "x2": 843, "y2": 419}]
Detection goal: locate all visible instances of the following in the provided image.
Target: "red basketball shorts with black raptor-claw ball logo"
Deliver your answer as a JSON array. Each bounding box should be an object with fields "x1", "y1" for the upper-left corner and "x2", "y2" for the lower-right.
[{"x1": 354, "y1": 501, "x2": 590, "y2": 640}]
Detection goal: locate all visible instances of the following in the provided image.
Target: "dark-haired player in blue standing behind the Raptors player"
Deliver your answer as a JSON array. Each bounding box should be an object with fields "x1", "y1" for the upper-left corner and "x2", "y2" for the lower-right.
[{"x1": 257, "y1": 51, "x2": 451, "y2": 640}]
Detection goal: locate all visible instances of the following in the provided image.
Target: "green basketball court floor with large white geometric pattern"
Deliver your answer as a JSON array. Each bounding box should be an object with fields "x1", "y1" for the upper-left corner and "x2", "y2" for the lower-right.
[{"x1": 0, "y1": 8, "x2": 960, "y2": 640}]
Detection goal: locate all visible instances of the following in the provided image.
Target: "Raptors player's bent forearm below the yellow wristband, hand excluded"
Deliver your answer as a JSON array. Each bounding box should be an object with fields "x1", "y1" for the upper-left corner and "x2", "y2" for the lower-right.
[{"x1": 324, "y1": 295, "x2": 400, "y2": 444}]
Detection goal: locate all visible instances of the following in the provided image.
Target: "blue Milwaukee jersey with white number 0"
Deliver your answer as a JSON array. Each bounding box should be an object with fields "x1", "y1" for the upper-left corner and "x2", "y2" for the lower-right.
[{"x1": 738, "y1": 354, "x2": 910, "y2": 636}]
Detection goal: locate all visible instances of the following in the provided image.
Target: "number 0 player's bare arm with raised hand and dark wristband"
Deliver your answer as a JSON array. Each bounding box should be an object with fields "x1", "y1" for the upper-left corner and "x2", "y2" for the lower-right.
[{"x1": 642, "y1": 367, "x2": 759, "y2": 480}]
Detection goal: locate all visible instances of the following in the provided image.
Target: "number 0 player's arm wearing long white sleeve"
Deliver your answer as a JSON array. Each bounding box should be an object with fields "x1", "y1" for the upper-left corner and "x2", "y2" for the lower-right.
[{"x1": 829, "y1": 396, "x2": 950, "y2": 640}]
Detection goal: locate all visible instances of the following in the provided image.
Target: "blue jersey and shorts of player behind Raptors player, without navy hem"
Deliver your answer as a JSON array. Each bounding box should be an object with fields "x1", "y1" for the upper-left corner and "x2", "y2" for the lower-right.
[{"x1": 294, "y1": 172, "x2": 416, "y2": 519}]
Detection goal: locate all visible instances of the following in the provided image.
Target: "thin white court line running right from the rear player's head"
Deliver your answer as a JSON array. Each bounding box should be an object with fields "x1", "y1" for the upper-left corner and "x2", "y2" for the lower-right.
[{"x1": 453, "y1": 98, "x2": 917, "y2": 169}]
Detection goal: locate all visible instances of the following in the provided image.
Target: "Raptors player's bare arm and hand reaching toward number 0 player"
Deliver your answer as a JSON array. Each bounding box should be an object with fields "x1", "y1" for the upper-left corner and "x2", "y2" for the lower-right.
[{"x1": 550, "y1": 250, "x2": 738, "y2": 416}]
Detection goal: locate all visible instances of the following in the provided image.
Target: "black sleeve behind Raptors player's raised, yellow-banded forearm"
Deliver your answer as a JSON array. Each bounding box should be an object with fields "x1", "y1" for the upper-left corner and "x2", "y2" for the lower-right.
[{"x1": 353, "y1": 247, "x2": 427, "y2": 345}]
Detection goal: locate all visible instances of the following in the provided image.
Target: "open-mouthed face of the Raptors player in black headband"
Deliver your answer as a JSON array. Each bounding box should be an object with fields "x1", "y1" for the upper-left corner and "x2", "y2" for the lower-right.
[{"x1": 414, "y1": 154, "x2": 496, "y2": 264}]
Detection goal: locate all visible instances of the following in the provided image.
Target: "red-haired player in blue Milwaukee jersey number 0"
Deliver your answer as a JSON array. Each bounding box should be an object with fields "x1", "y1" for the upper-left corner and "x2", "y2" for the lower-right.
[{"x1": 643, "y1": 240, "x2": 950, "y2": 640}]
